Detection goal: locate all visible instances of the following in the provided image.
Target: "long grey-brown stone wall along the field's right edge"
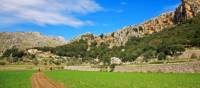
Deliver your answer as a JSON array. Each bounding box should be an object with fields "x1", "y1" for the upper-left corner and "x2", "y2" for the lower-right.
[{"x1": 114, "y1": 61, "x2": 200, "y2": 73}]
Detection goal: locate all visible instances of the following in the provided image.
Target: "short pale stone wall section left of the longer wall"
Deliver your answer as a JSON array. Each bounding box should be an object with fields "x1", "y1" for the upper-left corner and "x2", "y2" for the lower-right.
[{"x1": 64, "y1": 66, "x2": 100, "y2": 71}]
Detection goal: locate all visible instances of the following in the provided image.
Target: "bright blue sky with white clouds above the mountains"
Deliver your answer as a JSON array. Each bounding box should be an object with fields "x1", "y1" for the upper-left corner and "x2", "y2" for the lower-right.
[{"x1": 0, "y1": 0, "x2": 181, "y2": 40}]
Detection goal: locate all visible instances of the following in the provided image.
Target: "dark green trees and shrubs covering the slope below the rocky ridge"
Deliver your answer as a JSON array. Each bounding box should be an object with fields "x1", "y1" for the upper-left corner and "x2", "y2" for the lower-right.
[{"x1": 27, "y1": 15, "x2": 200, "y2": 64}]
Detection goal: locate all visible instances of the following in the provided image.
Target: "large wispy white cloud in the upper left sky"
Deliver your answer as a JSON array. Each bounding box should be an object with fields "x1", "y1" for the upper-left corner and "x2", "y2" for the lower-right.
[{"x1": 0, "y1": 0, "x2": 103, "y2": 27}]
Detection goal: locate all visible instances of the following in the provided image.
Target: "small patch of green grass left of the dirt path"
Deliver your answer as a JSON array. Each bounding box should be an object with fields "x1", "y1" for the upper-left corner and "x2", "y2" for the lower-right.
[{"x1": 0, "y1": 71, "x2": 34, "y2": 88}]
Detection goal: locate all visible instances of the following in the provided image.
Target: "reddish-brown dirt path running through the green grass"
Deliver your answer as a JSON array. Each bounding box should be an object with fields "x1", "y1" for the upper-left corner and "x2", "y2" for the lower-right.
[{"x1": 32, "y1": 72, "x2": 64, "y2": 88}]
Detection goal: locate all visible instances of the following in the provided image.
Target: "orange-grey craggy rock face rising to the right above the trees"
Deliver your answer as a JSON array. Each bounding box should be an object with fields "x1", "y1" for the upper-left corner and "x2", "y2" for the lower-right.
[{"x1": 92, "y1": 0, "x2": 200, "y2": 47}]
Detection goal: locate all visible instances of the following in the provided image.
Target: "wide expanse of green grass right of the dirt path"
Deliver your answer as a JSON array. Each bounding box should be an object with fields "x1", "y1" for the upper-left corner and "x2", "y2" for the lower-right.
[{"x1": 45, "y1": 71, "x2": 200, "y2": 88}]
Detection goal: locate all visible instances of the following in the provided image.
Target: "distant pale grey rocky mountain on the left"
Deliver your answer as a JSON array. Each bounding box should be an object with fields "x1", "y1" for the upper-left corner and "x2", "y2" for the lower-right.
[{"x1": 0, "y1": 32, "x2": 65, "y2": 53}]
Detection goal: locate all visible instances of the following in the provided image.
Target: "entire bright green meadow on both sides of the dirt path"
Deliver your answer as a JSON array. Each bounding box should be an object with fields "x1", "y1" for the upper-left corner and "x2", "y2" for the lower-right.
[{"x1": 0, "y1": 70, "x2": 200, "y2": 88}]
